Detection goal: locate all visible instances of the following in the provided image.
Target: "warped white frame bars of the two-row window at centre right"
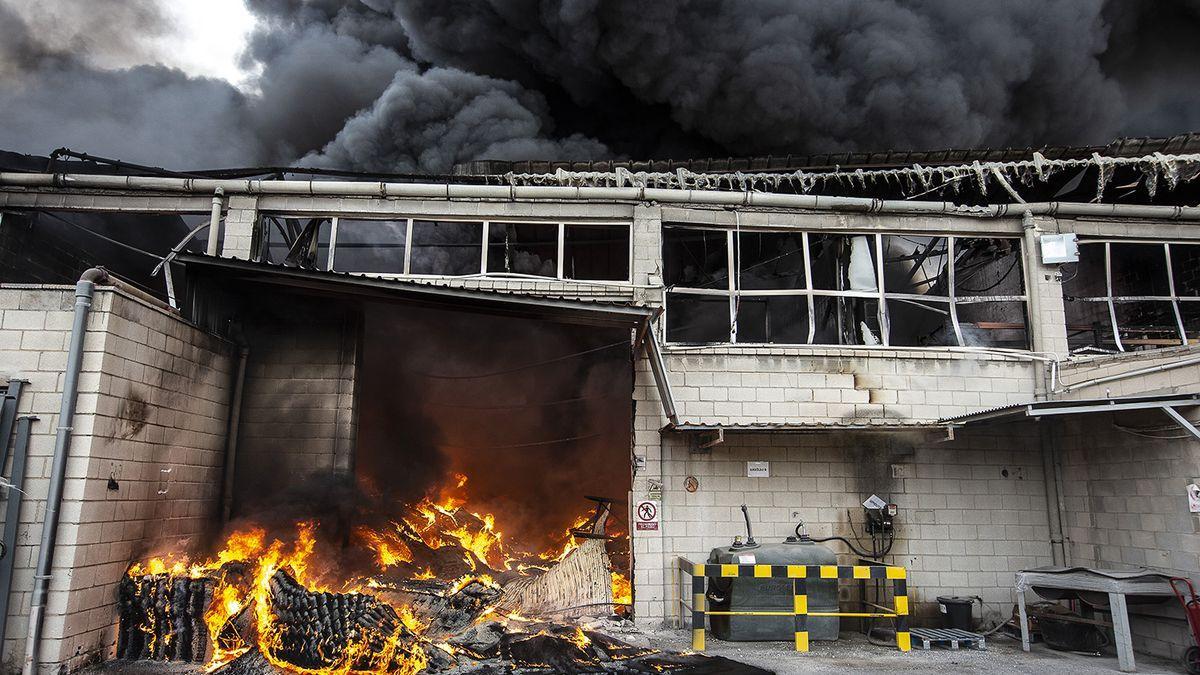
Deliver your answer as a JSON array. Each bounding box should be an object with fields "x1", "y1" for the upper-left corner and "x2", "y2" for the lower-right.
[{"x1": 661, "y1": 222, "x2": 1027, "y2": 351}]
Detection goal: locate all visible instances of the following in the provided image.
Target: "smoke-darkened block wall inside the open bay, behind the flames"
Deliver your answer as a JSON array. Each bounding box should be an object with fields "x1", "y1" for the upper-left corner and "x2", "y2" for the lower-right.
[{"x1": 234, "y1": 307, "x2": 361, "y2": 509}]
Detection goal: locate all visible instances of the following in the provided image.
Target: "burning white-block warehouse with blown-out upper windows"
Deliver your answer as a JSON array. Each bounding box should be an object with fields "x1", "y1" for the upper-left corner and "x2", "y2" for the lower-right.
[{"x1": 0, "y1": 132, "x2": 1200, "y2": 673}]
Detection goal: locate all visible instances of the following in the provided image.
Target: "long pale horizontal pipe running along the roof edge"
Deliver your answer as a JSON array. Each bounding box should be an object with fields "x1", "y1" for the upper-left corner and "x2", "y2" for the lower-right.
[{"x1": 7, "y1": 172, "x2": 1200, "y2": 221}]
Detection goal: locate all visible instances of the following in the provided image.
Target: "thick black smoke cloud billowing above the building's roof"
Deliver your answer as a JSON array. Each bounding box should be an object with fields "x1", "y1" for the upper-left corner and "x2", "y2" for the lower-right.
[{"x1": 0, "y1": 0, "x2": 1200, "y2": 173}]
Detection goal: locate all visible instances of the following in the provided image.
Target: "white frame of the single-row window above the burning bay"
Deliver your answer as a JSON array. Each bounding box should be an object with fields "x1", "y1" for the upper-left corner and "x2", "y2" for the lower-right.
[{"x1": 258, "y1": 211, "x2": 634, "y2": 281}]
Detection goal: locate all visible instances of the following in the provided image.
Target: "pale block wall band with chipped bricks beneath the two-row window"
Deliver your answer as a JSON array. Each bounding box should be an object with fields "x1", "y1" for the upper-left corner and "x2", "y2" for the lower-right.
[{"x1": 665, "y1": 346, "x2": 1038, "y2": 426}]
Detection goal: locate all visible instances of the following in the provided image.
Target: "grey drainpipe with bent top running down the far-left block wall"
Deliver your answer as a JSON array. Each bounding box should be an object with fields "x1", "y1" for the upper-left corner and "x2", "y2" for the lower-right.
[{"x1": 22, "y1": 267, "x2": 108, "y2": 675}]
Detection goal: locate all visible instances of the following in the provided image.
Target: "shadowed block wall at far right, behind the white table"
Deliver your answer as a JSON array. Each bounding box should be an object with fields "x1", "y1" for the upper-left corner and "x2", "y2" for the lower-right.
[{"x1": 1060, "y1": 414, "x2": 1200, "y2": 657}]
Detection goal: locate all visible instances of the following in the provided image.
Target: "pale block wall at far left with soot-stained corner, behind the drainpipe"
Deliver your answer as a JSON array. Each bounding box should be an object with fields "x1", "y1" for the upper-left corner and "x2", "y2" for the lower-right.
[{"x1": 0, "y1": 287, "x2": 233, "y2": 669}]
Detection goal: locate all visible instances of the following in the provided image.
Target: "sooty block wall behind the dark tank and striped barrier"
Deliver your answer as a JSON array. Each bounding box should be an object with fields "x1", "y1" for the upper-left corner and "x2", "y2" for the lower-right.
[{"x1": 662, "y1": 429, "x2": 1050, "y2": 625}]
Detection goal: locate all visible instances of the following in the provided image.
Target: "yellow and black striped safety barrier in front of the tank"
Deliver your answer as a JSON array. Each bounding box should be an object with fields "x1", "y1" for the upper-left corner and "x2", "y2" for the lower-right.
[{"x1": 678, "y1": 557, "x2": 912, "y2": 651}]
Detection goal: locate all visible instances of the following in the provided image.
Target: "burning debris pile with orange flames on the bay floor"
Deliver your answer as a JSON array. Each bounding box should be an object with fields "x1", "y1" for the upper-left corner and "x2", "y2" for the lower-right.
[{"x1": 118, "y1": 478, "x2": 729, "y2": 675}]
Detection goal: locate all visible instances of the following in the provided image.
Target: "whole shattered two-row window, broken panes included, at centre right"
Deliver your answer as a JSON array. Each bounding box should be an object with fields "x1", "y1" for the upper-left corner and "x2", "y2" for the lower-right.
[{"x1": 664, "y1": 228, "x2": 1028, "y2": 348}]
